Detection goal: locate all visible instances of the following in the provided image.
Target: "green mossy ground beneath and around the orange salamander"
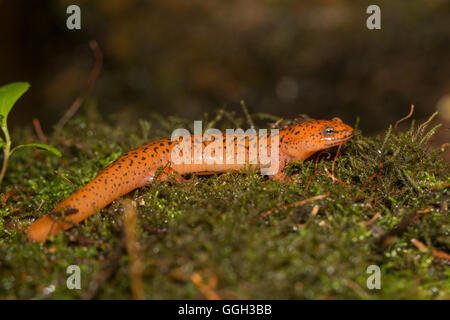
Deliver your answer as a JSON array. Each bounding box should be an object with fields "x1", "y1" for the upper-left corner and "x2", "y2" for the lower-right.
[{"x1": 0, "y1": 109, "x2": 450, "y2": 299}]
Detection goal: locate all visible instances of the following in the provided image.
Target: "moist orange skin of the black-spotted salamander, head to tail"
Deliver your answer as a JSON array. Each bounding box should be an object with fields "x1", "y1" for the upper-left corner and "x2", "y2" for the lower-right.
[{"x1": 28, "y1": 118, "x2": 353, "y2": 242}]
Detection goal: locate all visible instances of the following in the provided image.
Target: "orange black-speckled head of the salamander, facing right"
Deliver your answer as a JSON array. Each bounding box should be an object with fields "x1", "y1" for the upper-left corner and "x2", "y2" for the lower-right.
[{"x1": 280, "y1": 118, "x2": 353, "y2": 160}]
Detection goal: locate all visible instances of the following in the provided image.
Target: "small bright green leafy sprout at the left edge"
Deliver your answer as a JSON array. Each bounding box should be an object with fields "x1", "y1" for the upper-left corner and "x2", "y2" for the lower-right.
[{"x1": 0, "y1": 82, "x2": 61, "y2": 183}]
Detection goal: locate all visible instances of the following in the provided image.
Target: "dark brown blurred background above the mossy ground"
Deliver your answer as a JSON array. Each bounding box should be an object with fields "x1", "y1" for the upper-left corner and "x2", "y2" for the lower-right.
[{"x1": 0, "y1": 0, "x2": 450, "y2": 134}]
